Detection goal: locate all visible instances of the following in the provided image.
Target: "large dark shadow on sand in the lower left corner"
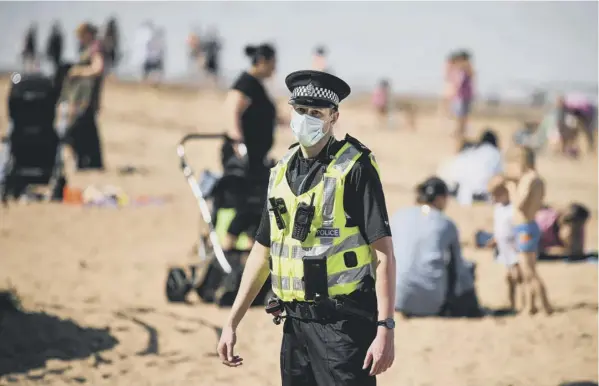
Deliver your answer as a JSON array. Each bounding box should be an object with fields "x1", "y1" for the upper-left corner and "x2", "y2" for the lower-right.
[{"x1": 0, "y1": 291, "x2": 118, "y2": 376}]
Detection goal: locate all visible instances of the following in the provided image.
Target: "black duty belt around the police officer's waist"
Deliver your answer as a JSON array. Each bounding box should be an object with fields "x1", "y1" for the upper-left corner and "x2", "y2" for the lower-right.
[{"x1": 283, "y1": 298, "x2": 377, "y2": 323}]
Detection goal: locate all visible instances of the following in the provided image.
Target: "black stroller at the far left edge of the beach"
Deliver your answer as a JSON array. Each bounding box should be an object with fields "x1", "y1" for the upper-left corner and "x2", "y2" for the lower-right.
[{"x1": 0, "y1": 74, "x2": 66, "y2": 204}]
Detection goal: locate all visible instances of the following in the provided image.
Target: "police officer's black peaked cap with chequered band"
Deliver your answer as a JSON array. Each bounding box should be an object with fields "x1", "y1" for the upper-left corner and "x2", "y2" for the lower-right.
[{"x1": 285, "y1": 70, "x2": 351, "y2": 107}]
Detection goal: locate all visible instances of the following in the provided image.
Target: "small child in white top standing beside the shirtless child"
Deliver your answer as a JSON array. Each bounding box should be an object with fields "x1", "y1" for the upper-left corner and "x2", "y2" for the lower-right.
[{"x1": 485, "y1": 175, "x2": 522, "y2": 310}]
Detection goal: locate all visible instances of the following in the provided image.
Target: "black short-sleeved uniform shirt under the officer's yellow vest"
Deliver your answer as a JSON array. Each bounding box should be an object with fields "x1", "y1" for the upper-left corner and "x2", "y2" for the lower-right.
[{"x1": 255, "y1": 138, "x2": 391, "y2": 247}]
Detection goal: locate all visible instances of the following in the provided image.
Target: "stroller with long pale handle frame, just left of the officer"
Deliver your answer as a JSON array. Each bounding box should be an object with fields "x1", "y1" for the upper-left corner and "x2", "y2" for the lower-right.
[{"x1": 166, "y1": 134, "x2": 272, "y2": 306}]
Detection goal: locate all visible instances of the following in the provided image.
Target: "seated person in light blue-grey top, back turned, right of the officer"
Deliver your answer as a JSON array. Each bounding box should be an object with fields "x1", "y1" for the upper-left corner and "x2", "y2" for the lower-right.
[{"x1": 390, "y1": 177, "x2": 480, "y2": 317}]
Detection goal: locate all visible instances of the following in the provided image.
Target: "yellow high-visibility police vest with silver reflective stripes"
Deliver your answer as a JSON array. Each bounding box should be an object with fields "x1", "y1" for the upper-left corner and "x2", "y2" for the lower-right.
[{"x1": 267, "y1": 142, "x2": 378, "y2": 302}]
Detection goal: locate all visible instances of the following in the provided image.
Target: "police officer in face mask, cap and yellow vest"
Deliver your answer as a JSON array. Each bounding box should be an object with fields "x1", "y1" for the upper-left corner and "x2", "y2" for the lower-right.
[{"x1": 218, "y1": 71, "x2": 395, "y2": 386}]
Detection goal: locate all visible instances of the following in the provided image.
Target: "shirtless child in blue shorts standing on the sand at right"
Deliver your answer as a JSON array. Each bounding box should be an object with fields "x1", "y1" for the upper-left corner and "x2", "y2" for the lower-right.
[{"x1": 506, "y1": 146, "x2": 552, "y2": 314}]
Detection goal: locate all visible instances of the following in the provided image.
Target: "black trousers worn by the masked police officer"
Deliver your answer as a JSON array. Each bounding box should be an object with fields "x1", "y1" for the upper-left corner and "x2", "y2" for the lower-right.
[{"x1": 281, "y1": 318, "x2": 377, "y2": 386}]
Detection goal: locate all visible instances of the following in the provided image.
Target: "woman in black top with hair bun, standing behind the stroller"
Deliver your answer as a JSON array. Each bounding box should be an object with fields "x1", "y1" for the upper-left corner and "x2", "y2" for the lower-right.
[{"x1": 223, "y1": 44, "x2": 285, "y2": 250}]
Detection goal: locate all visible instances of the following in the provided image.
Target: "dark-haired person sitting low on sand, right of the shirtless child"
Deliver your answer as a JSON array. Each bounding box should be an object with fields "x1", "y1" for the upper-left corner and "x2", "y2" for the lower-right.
[{"x1": 535, "y1": 203, "x2": 590, "y2": 260}]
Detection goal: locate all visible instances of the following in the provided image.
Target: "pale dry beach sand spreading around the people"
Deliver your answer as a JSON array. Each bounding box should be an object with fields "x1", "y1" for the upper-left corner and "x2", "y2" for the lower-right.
[{"x1": 0, "y1": 80, "x2": 597, "y2": 386}]
